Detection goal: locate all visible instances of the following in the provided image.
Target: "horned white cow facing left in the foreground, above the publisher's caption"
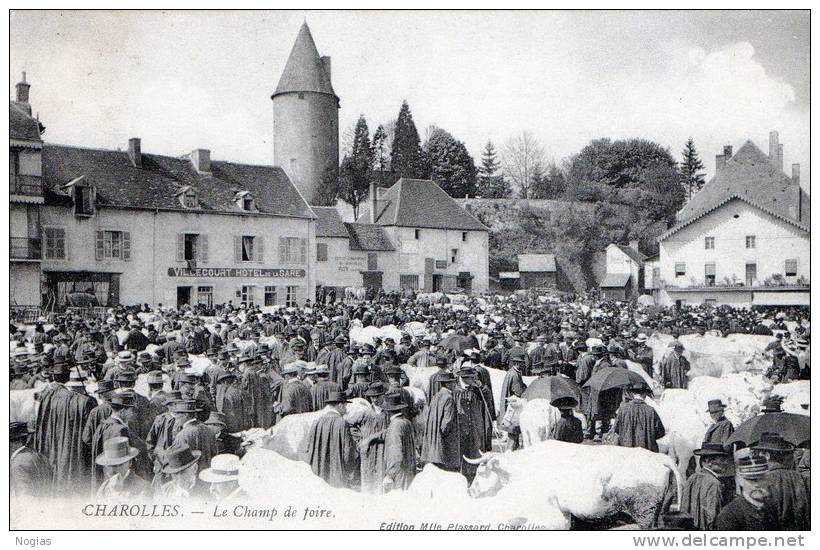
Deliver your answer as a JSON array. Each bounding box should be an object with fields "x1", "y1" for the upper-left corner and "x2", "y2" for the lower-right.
[{"x1": 470, "y1": 441, "x2": 683, "y2": 529}]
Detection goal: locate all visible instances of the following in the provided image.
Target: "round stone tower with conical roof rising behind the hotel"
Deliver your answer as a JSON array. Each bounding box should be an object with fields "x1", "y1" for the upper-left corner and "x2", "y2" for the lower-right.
[{"x1": 271, "y1": 23, "x2": 339, "y2": 204}]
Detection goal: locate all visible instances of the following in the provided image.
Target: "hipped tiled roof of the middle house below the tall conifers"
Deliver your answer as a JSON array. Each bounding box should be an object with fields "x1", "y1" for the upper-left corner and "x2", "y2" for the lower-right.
[{"x1": 359, "y1": 178, "x2": 489, "y2": 231}]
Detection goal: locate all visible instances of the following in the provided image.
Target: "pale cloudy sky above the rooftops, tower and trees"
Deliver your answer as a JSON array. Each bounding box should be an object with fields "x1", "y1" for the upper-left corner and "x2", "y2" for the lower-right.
[{"x1": 9, "y1": 10, "x2": 810, "y2": 186}]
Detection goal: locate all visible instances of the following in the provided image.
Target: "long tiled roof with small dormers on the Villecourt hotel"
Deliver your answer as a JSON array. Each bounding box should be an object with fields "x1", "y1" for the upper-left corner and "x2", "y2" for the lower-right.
[{"x1": 43, "y1": 144, "x2": 315, "y2": 219}]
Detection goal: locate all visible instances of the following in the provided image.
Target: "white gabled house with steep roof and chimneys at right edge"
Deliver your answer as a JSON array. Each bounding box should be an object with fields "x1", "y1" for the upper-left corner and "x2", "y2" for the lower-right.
[{"x1": 653, "y1": 132, "x2": 811, "y2": 306}]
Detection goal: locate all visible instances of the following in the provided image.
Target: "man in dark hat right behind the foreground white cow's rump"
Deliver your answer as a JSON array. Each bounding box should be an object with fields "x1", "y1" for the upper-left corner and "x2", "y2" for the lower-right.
[{"x1": 680, "y1": 443, "x2": 732, "y2": 530}]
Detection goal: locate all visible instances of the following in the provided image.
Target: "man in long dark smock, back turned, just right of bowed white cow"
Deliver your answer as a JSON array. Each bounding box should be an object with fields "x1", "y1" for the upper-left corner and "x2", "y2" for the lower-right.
[{"x1": 306, "y1": 392, "x2": 359, "y2": 488}]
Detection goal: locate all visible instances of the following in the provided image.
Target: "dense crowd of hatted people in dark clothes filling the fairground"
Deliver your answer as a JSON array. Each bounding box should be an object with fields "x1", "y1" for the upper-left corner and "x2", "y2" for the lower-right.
[{"x1": 10, "y1": 294, "x2": 811, "y2": 529}]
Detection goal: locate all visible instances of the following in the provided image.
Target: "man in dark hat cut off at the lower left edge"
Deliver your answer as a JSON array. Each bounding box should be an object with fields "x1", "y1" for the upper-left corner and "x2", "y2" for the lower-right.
[{"x1": 9, "y1": 422, "x2": 53, "y2": 498}]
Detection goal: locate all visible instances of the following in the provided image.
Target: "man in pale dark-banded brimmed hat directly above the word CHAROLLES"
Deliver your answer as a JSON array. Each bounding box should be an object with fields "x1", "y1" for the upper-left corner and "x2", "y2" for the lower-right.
[{"x1": 94, "y1": 436, "x2": 151, "y2": 502}]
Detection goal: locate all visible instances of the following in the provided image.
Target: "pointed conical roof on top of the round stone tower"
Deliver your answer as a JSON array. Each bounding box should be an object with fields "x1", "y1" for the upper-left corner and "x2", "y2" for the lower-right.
[{"x1": 271, "y1": 23, "x2": 338, "y2": 99}]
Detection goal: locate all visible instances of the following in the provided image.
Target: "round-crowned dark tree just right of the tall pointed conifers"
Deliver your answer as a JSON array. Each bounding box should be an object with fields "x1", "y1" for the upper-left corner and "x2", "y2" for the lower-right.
[{"x1": 424, "y1": 128, "x2": 477, "y2": 198}]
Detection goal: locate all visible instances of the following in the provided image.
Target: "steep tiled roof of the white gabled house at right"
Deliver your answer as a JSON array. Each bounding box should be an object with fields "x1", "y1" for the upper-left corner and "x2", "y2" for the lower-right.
[{"x1": 660, "y1": 141, "x2": 811, "y2": 239}]
